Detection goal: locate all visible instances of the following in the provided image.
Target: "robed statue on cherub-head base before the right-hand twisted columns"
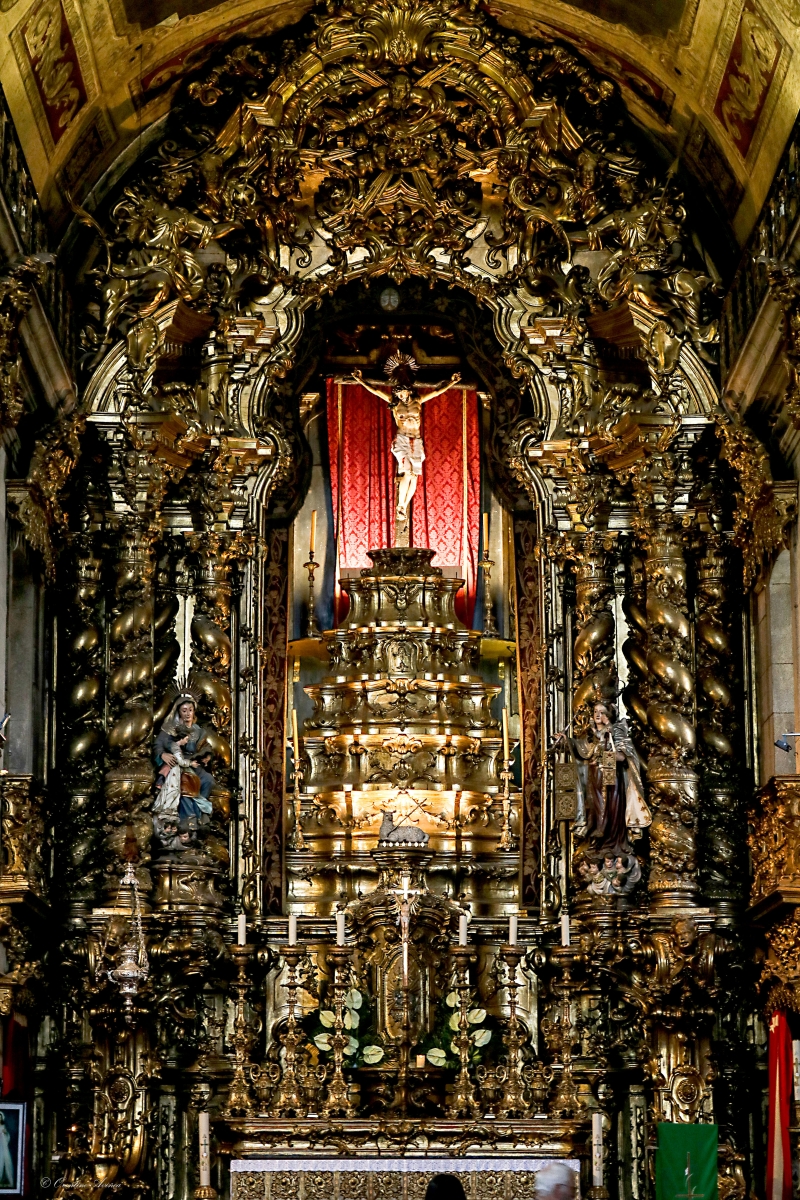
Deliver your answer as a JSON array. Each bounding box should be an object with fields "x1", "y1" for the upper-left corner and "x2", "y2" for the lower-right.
[{"x1": 557, "y1": 702, "x2": 652, "y2": 894}]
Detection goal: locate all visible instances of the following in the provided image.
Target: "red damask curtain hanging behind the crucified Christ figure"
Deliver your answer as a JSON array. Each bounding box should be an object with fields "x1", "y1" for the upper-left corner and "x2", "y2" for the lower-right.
[{"x1": 327, "y1": 379, "x2": 481, "y2": 625}]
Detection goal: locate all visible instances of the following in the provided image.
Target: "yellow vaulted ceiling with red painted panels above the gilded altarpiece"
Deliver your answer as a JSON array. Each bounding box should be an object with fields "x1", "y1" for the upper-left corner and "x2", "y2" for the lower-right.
[{"x1": 0, "y1": 0, "x2": 800, "y2": 249}]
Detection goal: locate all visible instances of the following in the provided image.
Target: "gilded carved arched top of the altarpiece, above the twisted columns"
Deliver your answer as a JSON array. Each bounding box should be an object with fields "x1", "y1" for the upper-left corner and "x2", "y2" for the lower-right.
[{"x1": 71, "y1": 0, "x2": 734, "y2": 528}]
